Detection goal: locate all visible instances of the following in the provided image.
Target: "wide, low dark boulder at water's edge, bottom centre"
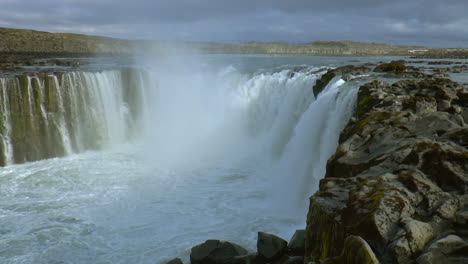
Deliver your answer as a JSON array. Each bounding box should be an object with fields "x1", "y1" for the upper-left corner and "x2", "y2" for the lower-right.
[{"x1": 190, "y1": 239, "x2": 248, "y2": 264}]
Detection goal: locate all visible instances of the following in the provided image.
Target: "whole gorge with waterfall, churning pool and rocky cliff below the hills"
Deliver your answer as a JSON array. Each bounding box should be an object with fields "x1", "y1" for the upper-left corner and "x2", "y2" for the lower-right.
[{"x1": 0, "y1": 30, "x2": 468, "y2": 264}]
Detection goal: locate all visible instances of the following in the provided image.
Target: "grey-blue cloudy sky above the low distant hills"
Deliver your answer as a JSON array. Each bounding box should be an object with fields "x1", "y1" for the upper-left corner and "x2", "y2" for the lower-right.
[{"x1": 0, "y1": 0, "x2": 468, "y2": 47}]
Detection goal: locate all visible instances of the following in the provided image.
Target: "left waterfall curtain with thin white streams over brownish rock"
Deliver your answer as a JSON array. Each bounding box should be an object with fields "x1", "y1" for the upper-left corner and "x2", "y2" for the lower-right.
[{"x1": 0, "y1": 68, "x2": 146, "y2": 166}]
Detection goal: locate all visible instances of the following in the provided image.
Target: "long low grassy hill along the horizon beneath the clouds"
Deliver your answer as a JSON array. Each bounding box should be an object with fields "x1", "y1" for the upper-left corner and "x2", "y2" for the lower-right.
[{"x1": 0, "y1": 28, "x2": 464, "y2": 56}]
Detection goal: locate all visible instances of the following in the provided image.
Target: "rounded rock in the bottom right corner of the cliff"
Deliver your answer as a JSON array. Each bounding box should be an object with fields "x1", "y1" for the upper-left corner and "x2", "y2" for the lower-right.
[{"x1": 417, "y1": 235, "x2": 468, "y2": 264}]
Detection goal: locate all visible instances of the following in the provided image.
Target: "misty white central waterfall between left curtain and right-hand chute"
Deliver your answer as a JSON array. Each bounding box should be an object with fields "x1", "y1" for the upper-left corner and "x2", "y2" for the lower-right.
[{"x1": 140, "y1": 62, "x2": 319, "y2": 168}]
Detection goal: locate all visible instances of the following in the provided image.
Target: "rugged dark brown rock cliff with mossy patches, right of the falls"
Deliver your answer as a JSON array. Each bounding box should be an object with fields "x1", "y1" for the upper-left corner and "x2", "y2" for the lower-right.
[{"x1": 305, "y1": 78, "x2": 468, "y2": 263}]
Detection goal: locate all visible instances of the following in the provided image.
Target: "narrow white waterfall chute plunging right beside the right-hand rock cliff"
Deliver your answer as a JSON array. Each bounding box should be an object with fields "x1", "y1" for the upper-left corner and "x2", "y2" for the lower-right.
[{"x1": 269, "y1": 78, "x2": 358, "y2": 215}]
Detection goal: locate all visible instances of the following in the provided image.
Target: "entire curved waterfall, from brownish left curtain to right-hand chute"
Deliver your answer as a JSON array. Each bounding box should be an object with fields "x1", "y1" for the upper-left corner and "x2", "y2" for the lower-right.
[{"x1": 0, "y1": 65, "x2": 357, "y2": 210}]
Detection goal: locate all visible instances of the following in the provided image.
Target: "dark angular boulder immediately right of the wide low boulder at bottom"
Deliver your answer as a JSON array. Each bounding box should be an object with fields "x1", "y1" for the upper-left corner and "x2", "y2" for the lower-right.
[{"x1": 257, "y1": 232, "x2": 288, "y2": 261}]
